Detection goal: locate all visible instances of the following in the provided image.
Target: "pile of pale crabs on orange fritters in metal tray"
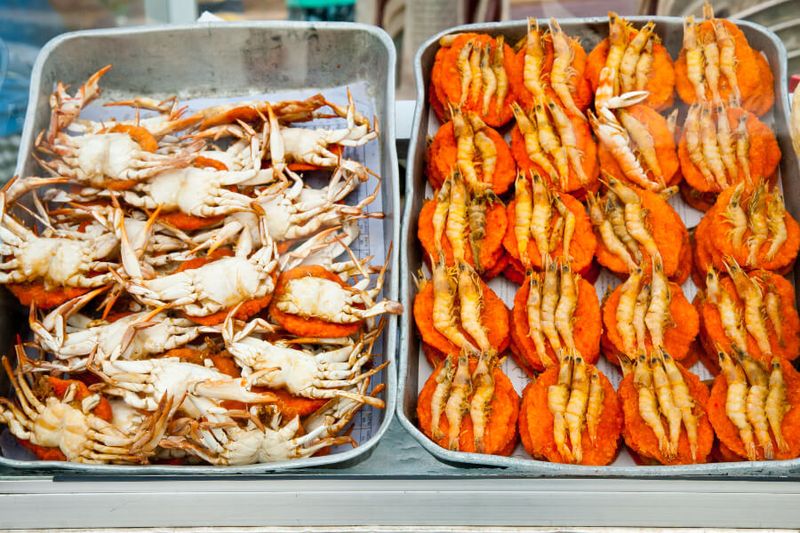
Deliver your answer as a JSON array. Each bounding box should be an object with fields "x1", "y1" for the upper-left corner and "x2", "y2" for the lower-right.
[{"x1": 0, "y1": 66, "x2": 402, "y2": 465}]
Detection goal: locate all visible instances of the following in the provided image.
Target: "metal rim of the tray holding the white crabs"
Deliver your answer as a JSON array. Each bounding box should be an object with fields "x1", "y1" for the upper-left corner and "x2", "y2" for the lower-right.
[{"x1": 0, "y1": 21, "x2": 401, "y2": 476}]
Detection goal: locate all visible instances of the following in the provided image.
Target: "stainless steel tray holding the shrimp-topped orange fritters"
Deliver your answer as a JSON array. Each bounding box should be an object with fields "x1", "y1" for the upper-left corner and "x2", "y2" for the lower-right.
[{"x1": 397, "y1": 17, "x2": 800, "y2": 477}]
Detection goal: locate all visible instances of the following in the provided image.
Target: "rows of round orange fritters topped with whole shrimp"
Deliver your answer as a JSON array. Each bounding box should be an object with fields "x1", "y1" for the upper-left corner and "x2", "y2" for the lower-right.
[{"x1": 413, "y1": 6, "x2": 800, "y2": 465}]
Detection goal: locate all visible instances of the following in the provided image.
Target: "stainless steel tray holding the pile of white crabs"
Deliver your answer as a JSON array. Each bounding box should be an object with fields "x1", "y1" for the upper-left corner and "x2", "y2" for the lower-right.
[{"x1": 0, "y1": 22, "x2": 400, "y2": 476}]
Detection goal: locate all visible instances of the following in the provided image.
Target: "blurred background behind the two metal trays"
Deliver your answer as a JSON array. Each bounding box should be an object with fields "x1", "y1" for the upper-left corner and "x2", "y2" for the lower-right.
[{"x1": 0, "y1": 0, "x2": 800, "y2": 181}]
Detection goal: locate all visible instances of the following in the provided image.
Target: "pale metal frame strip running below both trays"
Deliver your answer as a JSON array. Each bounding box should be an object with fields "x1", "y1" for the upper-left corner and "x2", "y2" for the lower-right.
[{"x1": 0, "y1": 478, "x2": 800, "y2": 531}]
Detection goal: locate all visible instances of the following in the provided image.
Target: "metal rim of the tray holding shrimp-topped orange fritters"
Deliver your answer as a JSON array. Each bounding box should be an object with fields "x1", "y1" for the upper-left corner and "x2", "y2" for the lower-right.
[{"x1": 397, "y1": 16, "x2": 800, "y2": 478}]
